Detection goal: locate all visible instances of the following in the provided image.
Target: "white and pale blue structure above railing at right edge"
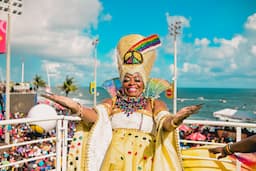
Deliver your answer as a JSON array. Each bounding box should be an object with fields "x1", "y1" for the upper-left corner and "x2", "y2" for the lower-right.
[{"x1": 213, "y1": 108, "x2": 256, "y2": 122}]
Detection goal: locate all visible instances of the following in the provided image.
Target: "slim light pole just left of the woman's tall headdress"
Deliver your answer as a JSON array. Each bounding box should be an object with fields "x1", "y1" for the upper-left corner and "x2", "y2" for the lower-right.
[{"x1": 92, "y1": 39, "x2": 99, "y2": 107}]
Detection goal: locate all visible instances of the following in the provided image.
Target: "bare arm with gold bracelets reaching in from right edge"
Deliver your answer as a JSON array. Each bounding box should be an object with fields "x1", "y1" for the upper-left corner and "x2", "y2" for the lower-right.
[{"x1": 209, "y1": 135, "x2": 256, "y2": 159}]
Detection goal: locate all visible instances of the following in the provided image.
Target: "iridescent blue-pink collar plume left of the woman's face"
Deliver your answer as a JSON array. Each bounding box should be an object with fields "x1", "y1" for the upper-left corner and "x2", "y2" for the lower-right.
[{"x1": 102, "y1": 78, "x2": 121, "y2": 97}]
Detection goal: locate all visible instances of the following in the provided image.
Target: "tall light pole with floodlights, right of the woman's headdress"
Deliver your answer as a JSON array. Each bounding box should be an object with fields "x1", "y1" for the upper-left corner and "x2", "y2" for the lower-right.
[{"x1": 169, "y1": 21, "x2": 181, "y2": 114}]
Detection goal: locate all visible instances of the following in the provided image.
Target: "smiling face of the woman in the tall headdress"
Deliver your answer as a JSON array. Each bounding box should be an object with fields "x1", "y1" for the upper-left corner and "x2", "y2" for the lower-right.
[{"x1": 123, "y1": 73, "x2": 144, "y2": 97}]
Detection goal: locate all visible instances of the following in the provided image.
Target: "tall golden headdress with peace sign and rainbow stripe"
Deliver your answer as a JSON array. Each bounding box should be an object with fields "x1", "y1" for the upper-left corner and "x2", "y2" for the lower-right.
[{"x1": 117, "y1": 34, "x2": 161, "y2": 86}]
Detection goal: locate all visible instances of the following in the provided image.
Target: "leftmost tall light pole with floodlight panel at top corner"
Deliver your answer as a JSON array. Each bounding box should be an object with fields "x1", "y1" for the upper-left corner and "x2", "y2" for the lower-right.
[{"x1": 0, "y1": 0, "x2": 22, "y2": 144}]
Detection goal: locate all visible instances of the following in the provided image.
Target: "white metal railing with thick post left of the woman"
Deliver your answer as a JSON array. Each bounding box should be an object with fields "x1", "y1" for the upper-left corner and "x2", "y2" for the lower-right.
[{"x1": 0, "y1": 115, "x2": 80, "y2": 171}]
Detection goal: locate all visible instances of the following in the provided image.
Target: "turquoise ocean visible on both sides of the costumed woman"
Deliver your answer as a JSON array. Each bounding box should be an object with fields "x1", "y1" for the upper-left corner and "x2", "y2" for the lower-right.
[{"x1": 52, "y1": 87, "x2": 256, "y2": 120}]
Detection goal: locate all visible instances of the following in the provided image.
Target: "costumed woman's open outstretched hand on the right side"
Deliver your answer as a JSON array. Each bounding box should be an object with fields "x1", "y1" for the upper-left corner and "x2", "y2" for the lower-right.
[{"x1": 172, "y1": 104, "x2": 202, "y2": 125}]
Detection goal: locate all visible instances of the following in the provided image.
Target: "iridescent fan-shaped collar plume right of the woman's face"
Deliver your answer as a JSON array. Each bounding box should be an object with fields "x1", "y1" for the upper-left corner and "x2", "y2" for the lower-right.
[{"x1": 145, "y1": 78, "x2": 171, "y2": 98}]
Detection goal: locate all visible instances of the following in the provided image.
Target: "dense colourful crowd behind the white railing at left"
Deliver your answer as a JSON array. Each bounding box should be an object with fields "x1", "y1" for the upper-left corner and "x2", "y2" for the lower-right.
[{"x1": 0, "y1": 101, "x2": 76, "y2": 171}]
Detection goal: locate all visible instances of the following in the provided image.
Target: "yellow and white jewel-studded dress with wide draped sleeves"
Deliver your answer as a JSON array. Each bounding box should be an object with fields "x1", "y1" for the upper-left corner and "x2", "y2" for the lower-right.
[{"x1": 68, "y1": 105, "x2": 182, "y2": 171}]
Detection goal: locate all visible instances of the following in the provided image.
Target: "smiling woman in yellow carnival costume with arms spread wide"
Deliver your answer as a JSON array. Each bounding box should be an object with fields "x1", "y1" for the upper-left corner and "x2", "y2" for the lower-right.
[{"x1": 43, "y1": 34, "x2": 201, "y2": 171}]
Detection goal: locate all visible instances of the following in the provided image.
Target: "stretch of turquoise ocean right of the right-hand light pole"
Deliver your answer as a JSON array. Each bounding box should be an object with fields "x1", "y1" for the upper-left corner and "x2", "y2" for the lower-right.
[{"x1": 177, "y1": 88, "x2": 256, "y2": 120}]
